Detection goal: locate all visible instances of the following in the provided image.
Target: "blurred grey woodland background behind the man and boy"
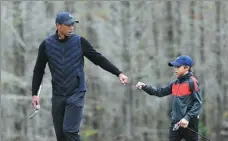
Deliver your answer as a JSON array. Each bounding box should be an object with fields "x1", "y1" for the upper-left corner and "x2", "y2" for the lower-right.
[{"x1": 1, "y1": 0, "x2": 228, "y2": 141}]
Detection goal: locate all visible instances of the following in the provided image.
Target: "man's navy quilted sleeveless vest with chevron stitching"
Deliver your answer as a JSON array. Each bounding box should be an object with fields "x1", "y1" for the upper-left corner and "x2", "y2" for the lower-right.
[{"x1": 45, "y1": 34, "x2": 86, "y2": 96}]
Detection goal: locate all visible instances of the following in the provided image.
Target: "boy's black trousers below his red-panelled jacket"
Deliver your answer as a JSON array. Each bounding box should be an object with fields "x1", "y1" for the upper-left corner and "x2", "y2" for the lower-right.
[{"x1": 169, "y1": 118, "x2": 199, "y2": 141}]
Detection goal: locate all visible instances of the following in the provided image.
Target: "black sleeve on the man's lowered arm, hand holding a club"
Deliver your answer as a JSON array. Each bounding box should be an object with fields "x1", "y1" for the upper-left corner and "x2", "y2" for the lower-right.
[{"x1": 32, "y1": 41, "x2": 47, "y2": 95}]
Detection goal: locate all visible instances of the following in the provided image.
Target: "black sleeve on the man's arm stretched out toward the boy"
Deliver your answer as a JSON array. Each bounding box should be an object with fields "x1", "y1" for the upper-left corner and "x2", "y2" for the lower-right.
[{"x1": 81, "y1": 37, "x2": 121, "y2": 76}]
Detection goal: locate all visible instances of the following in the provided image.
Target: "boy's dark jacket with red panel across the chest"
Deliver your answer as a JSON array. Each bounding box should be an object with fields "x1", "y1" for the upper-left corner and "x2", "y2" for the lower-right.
[{"x1": 142, "y1": 72, "x2": 202, "y2": 123}]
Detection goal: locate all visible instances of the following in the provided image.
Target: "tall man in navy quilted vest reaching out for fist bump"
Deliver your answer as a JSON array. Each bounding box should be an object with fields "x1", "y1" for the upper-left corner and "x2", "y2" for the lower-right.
[{"x1": 32, "y1": 12, "x2": 128, "y2": 141}]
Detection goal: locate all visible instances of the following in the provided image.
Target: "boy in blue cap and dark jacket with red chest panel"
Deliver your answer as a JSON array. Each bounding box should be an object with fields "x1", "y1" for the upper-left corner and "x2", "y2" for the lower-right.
[{"x1": 136, "y1": 55, "x2": 202, "y2": 141}]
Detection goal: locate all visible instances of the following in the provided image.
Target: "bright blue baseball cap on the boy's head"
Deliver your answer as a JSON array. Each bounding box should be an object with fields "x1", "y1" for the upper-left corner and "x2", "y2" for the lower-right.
[{"x1": 168, "y1": 55, "x2": 194, "y2": 67}]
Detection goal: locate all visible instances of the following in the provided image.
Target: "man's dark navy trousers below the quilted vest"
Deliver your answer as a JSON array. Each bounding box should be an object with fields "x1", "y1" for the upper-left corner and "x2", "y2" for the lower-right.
[{"x1": 52, "y1": 92, "x2": 85, "y2": 141}]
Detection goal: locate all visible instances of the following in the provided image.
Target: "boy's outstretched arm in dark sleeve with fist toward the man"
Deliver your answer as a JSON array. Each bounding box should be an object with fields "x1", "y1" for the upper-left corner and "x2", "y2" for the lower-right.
[{"x1": 136, "y1": 82, "x2": 172, "y2": 97}]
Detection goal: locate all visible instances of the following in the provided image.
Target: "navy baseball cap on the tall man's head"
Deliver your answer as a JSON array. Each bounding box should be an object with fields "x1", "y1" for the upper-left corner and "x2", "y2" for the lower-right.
[{"x1": 55, "y1": 11, "x2": 79, "y2": 25}]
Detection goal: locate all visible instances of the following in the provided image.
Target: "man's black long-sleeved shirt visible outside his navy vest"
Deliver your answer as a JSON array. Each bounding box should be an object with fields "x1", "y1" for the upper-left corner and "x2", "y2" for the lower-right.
[{"x1": 32, "y1": 37, "x2": 121, "y2": 95}]
